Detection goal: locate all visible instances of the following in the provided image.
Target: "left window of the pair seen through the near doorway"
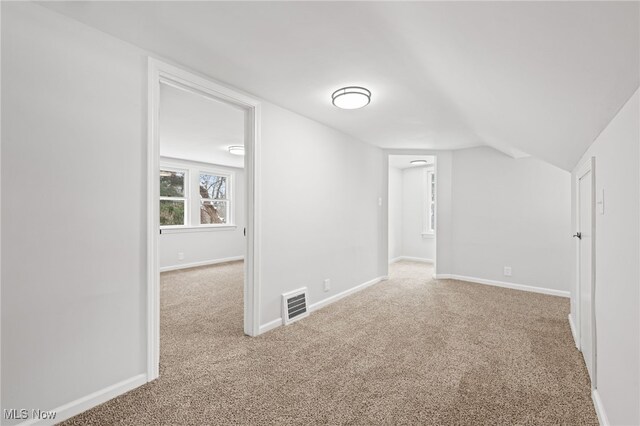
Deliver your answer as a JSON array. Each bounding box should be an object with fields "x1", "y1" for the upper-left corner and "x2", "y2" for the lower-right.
[{"x1": 160, "y1": 168, "x2": 187, "y2": 226}]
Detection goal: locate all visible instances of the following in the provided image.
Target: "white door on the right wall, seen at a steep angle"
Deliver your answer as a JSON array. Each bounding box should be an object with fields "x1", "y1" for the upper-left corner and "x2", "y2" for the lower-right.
[{"x1": 578, "y1": 169, "x2": 595, "y2": 385}]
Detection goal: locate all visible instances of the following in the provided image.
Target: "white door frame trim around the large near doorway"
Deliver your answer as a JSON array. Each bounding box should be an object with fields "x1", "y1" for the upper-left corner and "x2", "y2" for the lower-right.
[{"x1": 147, "y1": 57, "x2": 261, "y2": 381}]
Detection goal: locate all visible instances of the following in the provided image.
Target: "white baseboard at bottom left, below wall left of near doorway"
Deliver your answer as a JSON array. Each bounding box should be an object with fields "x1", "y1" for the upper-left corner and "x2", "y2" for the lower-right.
[{"x1": 19, "y1": 374, "x2": 147, "y2": 426}]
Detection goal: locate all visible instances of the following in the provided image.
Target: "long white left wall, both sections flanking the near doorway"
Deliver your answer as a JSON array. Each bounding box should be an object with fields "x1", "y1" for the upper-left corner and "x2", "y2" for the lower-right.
[{"x1": 1, "y1": 2, "x2": 387, "y2": 422}]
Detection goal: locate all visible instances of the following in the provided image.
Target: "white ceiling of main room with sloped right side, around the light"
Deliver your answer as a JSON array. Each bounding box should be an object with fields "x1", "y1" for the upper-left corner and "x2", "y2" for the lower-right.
[{"x1": 42, "y1": 1, "x2": 640, "y2": 170}]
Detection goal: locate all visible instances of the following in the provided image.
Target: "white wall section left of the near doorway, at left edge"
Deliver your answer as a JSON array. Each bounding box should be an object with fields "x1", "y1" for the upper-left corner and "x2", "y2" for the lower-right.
[{"x1": 1, "y1": 3, "x2": 146, "y2": 422}]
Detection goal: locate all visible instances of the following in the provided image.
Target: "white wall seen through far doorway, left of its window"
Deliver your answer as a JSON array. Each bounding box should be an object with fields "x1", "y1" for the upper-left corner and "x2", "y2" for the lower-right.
[{"x1": 402, "y1": 167, "x2": 438, "y2": 261}]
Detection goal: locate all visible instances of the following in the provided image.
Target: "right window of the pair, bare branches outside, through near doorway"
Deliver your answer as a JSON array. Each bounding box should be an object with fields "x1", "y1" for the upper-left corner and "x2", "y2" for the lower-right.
[{"x1": 200, "y1": 172, "x2": 230, "y2": 225}]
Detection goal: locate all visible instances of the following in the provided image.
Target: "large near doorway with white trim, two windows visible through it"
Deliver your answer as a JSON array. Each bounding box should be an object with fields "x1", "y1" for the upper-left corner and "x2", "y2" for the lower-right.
[{"x1": 147, "y1": 59, "x2": 260, "y2": 381}]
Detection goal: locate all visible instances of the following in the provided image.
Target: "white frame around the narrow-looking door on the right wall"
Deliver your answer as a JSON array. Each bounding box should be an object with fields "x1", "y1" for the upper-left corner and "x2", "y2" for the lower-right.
[{"x1": 575, "y1": 157, "x2": 598, "y2": 389}]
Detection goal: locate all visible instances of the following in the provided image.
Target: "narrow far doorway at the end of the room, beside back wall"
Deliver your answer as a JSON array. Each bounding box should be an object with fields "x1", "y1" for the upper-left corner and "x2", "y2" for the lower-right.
[{"x1": 388, "y1": 155, "x2": 437, "y2": 275}]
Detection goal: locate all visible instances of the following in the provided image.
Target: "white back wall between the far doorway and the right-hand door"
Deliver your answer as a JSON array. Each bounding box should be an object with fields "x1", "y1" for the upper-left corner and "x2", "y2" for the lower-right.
[{"x1": 448, "y1": 147, "x2": 572, "y2": 292}]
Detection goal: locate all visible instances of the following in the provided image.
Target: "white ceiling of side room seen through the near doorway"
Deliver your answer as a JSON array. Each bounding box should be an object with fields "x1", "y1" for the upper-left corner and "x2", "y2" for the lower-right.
[{"x1": 159, "y1": 84, "x2": 245, "y2": 167}]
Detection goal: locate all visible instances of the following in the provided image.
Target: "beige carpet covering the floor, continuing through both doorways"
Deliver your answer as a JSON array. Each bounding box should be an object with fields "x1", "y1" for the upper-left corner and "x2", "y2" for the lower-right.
[{"x1": 66, "y1": 262, "x2": 597, "y2": 425}]
